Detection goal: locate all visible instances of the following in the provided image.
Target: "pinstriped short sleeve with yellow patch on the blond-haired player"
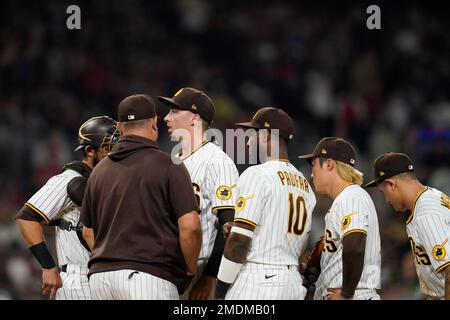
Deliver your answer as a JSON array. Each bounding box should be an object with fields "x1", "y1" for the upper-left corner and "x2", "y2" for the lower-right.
[{"x1": 337, "y1": 197, "x2": 369, "y2": 238}]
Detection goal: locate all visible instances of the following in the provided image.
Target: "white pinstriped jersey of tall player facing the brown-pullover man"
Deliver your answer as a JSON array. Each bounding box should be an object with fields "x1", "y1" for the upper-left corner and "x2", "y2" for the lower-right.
[{"x1": 182, "y1": 141, "x2": 239, "y2": 259}]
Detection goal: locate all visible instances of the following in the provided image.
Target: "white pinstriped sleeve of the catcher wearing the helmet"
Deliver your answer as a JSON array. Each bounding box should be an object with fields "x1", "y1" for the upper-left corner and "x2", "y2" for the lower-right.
[{"x1": 25, "y1": 175, "x2": 73, "y2": 223}]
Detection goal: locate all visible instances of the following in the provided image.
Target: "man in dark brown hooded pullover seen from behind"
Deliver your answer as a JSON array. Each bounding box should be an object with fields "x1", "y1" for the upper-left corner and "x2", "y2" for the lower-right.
[{"x1": 80, "y1": 94, "x2": 202, "y2": 300}]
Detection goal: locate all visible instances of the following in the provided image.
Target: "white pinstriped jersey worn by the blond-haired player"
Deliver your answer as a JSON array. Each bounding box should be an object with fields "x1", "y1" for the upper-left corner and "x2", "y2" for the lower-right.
[{"x1": 314, "y1": 184, "x2": 381, "y2": 300}]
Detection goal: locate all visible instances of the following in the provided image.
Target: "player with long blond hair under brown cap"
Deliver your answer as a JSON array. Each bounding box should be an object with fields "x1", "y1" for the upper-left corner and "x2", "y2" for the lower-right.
[{"x1": 299, "y1": 137, "x2": 381, "y2": 300}]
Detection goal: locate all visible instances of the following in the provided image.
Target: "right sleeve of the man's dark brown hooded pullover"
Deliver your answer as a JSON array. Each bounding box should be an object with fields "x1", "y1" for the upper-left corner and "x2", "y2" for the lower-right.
[{"x1": 167, "y1": 163, "x2": 200, "y2": 218}]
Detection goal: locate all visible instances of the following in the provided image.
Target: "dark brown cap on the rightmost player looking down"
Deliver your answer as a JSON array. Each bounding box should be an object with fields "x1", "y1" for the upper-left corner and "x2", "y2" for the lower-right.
[{"x1": 364, "y1": 152, "x2": 414, "y2": 188}]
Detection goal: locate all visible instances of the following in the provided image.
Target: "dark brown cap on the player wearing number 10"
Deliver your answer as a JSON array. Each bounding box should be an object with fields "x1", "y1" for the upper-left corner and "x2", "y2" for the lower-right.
[{"x1": 236, "y1": 107, "x2": 294, "y2": 140}]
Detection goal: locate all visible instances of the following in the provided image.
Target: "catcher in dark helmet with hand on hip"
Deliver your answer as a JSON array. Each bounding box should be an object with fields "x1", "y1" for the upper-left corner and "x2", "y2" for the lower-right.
[{"x1": 15, "y1": 116, "x2": 118, "y2": 300}]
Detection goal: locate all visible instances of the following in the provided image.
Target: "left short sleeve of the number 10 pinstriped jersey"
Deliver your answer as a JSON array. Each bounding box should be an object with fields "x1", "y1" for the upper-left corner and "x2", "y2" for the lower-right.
[{"x1": 234, "y1": 168, "x2": 269, "y2": 227}]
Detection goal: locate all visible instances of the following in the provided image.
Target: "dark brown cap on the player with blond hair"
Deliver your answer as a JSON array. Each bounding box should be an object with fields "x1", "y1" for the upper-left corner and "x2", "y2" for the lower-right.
[{"x1": 299, "y1": 137, "x2": 356, "y2": 167}]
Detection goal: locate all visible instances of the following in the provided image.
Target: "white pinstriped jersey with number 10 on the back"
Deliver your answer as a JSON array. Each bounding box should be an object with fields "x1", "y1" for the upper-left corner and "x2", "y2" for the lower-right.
[{"x1": 234, "y1": 160, "x2": 316, "y2": 266}]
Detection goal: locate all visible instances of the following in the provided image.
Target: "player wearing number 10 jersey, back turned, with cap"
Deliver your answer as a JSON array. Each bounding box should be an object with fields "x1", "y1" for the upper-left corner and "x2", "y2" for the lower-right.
[{"x1": 215, "y1": 107, "x2": 316, "y2": 300}]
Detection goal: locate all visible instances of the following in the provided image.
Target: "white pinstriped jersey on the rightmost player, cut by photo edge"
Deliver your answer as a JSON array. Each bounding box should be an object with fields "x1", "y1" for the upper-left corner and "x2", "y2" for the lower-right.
[{"x1": 406, "y1": 188, "x2": 450, "y2": 299}]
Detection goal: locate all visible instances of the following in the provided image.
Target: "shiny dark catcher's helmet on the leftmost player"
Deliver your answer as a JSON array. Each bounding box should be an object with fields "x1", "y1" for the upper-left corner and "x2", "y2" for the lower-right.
[{"x1": 75, "y1": 116, "x2": 120, "y2": 151}]
